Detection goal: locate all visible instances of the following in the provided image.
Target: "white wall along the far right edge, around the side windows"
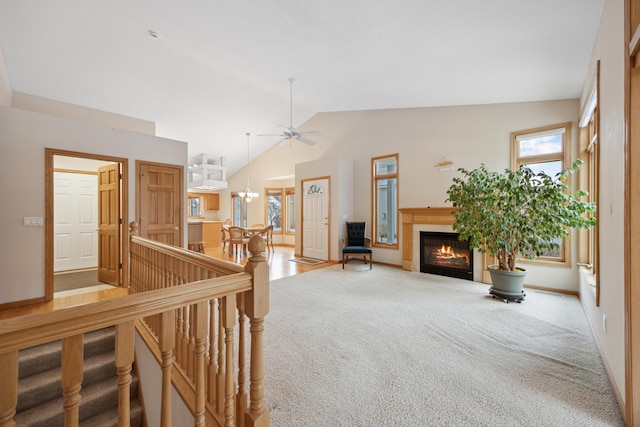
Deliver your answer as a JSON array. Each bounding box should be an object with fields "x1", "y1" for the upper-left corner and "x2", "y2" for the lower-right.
[{"x1": 580, "y1": 0, "x2": 624, "y2": 406}]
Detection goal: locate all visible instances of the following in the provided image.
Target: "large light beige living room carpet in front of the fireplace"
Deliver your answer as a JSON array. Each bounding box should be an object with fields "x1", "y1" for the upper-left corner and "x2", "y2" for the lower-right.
[{"x1": 265, "y1": 265, "x2": 624, "y2": 427}]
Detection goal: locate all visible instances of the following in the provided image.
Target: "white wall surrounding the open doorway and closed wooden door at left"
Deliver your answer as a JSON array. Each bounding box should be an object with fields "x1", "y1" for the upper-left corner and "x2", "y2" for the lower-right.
[{"x1": 0, "y1": 107, "x2": 187, "y2": 304}]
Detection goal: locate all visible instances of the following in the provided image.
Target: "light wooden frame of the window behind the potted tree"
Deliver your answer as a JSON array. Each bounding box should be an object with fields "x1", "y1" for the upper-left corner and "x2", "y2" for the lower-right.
[{"x1": 511, "y1": 122, "x2": 572, "y2": 267}]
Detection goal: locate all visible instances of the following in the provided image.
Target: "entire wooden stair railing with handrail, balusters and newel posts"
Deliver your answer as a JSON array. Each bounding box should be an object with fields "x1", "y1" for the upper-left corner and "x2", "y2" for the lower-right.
[{"x1": 0, "y1": 226, "x2": 270, "y2": 427}]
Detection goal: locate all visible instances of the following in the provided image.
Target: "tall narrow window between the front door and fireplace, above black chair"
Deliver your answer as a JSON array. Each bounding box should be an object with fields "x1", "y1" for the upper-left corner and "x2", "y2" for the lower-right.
[{"x1": 371, "y1": 154, "x2": 398, "y2": 249}]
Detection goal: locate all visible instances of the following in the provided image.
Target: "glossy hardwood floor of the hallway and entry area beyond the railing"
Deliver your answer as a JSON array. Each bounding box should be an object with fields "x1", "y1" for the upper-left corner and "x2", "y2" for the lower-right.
[{"x1": 0, "y1": 246, "x2": 336, "y2": 320}]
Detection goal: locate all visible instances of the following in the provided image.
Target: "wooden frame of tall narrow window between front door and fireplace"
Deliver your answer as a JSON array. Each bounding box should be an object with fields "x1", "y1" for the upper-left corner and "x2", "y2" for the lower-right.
[{"x1": 371, "y1": 153, "x2": 400, "y2": 250}]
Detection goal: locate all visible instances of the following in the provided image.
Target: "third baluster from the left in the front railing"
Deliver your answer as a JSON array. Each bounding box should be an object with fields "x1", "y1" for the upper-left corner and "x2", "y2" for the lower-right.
[{"x1": 116, "y1": 320, "x2": 134, "y2": 427}]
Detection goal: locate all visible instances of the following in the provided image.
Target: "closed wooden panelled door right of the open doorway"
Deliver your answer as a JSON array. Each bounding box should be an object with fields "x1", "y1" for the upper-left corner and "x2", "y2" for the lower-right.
[{"x1": 137, "y1": 162, "x2": 183, "y2": 247}]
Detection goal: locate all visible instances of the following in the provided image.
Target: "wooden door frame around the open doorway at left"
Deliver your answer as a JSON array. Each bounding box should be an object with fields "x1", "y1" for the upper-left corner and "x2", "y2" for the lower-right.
[{"x1": 44, "y1": 148, "x2": 129, "y2": 301}]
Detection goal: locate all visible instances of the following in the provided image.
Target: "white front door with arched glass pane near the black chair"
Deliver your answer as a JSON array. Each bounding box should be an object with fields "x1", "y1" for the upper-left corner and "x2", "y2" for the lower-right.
[{"x1": 302, "y1": 179, "x2": 329, "y2": 261}]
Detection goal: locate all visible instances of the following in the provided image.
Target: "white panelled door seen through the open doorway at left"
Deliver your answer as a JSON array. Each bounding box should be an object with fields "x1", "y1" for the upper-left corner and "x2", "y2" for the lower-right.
[{"x1": 53, "y1": 172, "x2": 98, "y2": 272}]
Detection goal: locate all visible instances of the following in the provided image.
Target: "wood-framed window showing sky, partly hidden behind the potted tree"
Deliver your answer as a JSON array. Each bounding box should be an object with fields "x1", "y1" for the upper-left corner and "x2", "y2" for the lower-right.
[{"x1": 511, "y1": 123, "x2": 571, "y2": 265}]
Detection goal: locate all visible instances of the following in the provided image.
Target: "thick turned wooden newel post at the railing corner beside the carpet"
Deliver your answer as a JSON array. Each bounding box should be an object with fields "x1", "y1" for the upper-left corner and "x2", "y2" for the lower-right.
[{"x1": 244, "y1": 235, "x2": 270, "y2": 427}]
